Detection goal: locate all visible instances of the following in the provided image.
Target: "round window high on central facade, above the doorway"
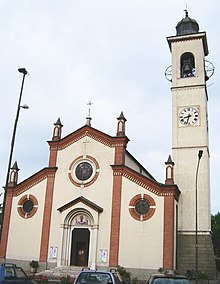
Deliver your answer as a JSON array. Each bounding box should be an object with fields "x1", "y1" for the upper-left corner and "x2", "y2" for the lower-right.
[{"x1": 68, "y1": 155, "x2": 99, "y2": 187}]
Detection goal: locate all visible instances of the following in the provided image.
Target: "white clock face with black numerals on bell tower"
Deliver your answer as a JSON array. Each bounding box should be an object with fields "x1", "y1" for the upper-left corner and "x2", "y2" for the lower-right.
[{"x1": 179, "y1": 107, "x2": 199, "y2": 125}]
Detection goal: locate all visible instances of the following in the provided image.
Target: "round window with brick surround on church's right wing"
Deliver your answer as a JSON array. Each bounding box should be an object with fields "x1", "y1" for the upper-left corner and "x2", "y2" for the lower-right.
[{"x1": 129, "y1": 194, "x2": 156, "y2": 221}]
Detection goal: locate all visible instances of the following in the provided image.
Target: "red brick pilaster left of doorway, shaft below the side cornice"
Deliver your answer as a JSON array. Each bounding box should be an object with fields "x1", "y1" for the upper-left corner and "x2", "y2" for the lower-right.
[{"x1": 40, "y1": 169, "x2": 55, "y2": 262}]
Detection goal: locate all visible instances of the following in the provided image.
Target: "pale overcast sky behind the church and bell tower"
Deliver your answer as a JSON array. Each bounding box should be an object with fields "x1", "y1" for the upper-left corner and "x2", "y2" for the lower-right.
[{"x1": 0, "y1": 0, "x2": 220, "y2": 214}]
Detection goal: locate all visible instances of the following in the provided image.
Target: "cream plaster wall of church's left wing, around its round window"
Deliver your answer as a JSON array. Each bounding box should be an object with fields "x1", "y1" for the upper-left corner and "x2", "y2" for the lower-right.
[{"x1": 6, "y1": 179, "x2": 46, "y2": 260}]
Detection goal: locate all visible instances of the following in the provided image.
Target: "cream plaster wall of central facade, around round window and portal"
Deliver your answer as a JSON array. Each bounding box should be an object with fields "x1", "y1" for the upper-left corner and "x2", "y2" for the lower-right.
[{"x1": 49, "y1": 137, "x2": 114, "y2": 264}]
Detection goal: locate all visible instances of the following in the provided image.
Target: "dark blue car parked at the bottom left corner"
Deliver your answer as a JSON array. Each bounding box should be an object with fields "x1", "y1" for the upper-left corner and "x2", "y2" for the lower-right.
[{"x1": 0, "y1": 263, "x2": 36, "y2": 284}]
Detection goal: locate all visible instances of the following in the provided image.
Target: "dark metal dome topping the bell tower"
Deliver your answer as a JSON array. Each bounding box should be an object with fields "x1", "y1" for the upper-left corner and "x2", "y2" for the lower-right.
[{"x1": 176, "y1": 10, "x2": 199, "y2": 36}]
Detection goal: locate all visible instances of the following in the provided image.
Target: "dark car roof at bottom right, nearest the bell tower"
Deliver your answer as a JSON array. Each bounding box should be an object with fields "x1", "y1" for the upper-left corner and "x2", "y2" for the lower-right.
[{"x1": 147, "y1": 274, "x2": 191, "y2": 284}]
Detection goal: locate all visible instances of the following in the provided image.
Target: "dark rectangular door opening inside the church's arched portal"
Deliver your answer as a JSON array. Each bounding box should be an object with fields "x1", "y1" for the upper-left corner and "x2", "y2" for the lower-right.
[{"x1": 70, "y1": 228, "x2": 90, "y2": 266}]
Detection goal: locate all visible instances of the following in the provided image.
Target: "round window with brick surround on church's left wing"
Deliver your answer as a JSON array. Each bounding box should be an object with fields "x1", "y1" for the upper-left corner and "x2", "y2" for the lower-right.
[{"x1": 17, "y1": 194, "x2": 38, "y2": 218}]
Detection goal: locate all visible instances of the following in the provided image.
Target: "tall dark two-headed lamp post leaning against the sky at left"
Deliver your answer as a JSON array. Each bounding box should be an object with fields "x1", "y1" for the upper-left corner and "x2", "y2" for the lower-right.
[{"x1": 1, "y1": 68, "x2": 29, "y2": 241}]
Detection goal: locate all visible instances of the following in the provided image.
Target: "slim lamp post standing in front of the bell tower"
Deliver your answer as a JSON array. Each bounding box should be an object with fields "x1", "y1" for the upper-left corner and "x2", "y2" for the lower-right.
[{"x1": 195, "y1": 150, "x2": 203, "y2": 284}]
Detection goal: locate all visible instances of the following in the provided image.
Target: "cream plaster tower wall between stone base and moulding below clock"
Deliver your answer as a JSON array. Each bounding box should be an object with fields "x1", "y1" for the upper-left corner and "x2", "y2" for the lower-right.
[{"x1": 173, "y1": 148, "x2": 211, "y2": 232}]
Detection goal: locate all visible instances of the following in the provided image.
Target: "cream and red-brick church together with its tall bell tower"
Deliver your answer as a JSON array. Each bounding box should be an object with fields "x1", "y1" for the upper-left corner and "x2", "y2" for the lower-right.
[{"x1": 0, "y1": 12, "x2": 215, "y2": 279}]
